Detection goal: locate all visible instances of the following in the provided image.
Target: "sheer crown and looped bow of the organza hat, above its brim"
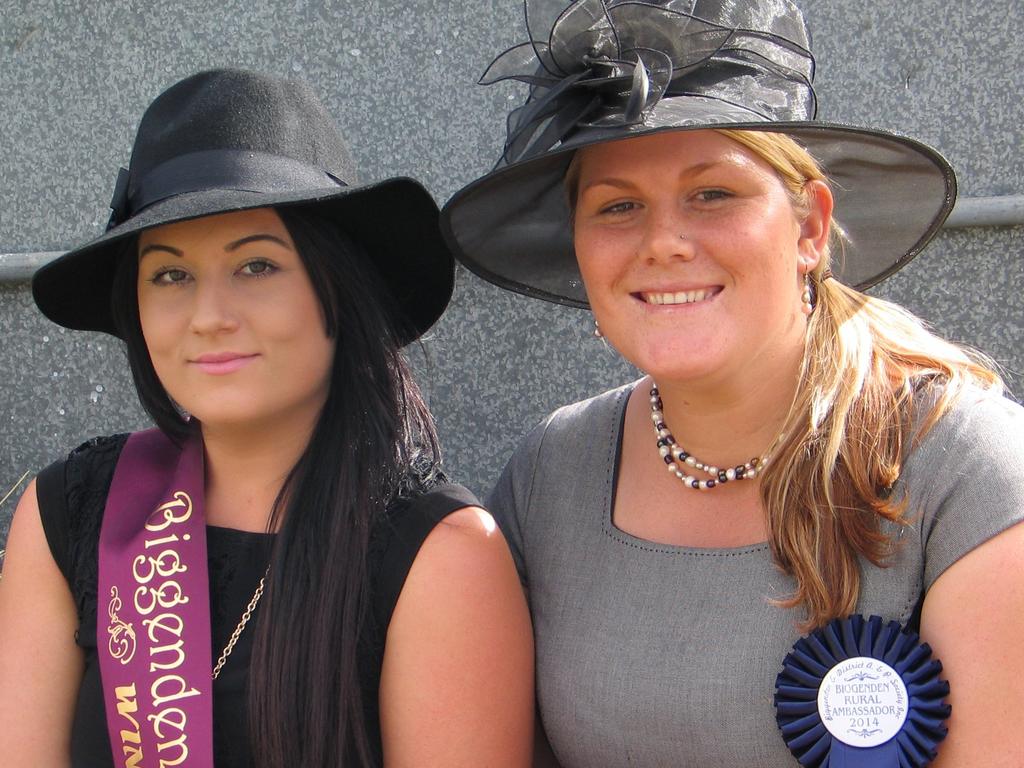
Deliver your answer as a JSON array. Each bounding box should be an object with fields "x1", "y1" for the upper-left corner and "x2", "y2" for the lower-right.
[{"x1": 480, "y1": 0, "x2": 816, "y2": 166}]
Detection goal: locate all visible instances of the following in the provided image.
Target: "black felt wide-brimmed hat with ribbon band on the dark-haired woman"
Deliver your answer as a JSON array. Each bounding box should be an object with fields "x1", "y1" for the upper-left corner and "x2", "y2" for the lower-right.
[{"x1": 32, "y1": 70, "x2": 454, "y2": 343}]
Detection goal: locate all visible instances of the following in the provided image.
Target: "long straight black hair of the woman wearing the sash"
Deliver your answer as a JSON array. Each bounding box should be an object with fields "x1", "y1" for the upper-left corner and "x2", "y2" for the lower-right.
[{"x1": 114, "y1": 207, "x2": 439, "y2": 768}]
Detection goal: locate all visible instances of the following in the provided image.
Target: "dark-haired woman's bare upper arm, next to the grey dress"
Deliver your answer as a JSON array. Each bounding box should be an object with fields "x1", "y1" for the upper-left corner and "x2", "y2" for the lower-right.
[{"x1": 380, "y1": 507, "x2": 534, "y2": 768}]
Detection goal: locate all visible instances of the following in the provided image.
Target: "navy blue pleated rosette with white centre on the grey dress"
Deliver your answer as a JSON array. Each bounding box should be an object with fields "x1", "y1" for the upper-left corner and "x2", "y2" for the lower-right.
[{"x1": 775, "y1": 615, "x2": 950, "y2": 768}]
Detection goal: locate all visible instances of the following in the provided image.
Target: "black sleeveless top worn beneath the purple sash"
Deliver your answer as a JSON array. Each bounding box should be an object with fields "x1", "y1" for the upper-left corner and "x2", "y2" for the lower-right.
[{"x1": 36, "y1": 435, "x2": 479, "y2": 768}]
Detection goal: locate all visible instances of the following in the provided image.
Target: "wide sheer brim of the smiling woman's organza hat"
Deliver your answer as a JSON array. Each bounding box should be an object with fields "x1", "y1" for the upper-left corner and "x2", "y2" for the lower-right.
[{"x1": 441, "y1": 112, "x2": 956, "y2": 308}]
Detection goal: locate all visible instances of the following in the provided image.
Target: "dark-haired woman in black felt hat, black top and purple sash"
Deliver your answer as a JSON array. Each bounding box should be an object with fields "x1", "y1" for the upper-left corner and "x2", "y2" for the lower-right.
[{"x1": 0, "y1": 71, "x2": 532, "y2": 767}]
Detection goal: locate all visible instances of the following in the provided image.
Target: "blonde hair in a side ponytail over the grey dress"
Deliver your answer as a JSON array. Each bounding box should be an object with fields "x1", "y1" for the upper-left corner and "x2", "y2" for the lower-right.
[{"x1": 719, "y1": 130, "x2": 1002, "y2": 629}]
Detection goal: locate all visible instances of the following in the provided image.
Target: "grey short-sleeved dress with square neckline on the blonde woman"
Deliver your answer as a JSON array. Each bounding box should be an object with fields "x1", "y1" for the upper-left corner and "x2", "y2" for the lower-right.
[{"x1": 487, "y1": 385, "x2": 1024, "y2": 768}]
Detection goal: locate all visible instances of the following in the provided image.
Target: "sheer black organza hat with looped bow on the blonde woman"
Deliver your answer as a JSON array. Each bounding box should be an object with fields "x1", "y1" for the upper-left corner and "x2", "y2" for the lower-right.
[{"x1": 441, "y1": 0, "x2": 956, "y2": 307}]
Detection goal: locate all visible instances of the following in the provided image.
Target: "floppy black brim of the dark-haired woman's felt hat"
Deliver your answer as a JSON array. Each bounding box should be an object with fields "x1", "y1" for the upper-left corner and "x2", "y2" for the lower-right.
[{"x1": 32, "y1": 178, "x2": 455, "y2": 344}]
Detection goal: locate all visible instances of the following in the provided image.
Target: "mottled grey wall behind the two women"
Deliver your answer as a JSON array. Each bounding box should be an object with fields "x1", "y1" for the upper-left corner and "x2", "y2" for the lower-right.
[{"x1": 0, "y1": 0, "x2": 1024, "y2": 546}]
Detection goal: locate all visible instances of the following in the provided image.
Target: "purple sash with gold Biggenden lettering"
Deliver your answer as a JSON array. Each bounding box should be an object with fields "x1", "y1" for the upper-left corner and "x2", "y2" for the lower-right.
[{"x1": 96, "y1": 429, "x2": 213, "y2": 768}]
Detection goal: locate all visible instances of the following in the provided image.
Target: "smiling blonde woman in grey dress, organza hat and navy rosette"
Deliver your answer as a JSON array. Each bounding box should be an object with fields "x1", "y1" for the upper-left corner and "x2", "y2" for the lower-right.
[{"x1": 442, "y1": 0, "x2": 1024, "y2": 768}]
